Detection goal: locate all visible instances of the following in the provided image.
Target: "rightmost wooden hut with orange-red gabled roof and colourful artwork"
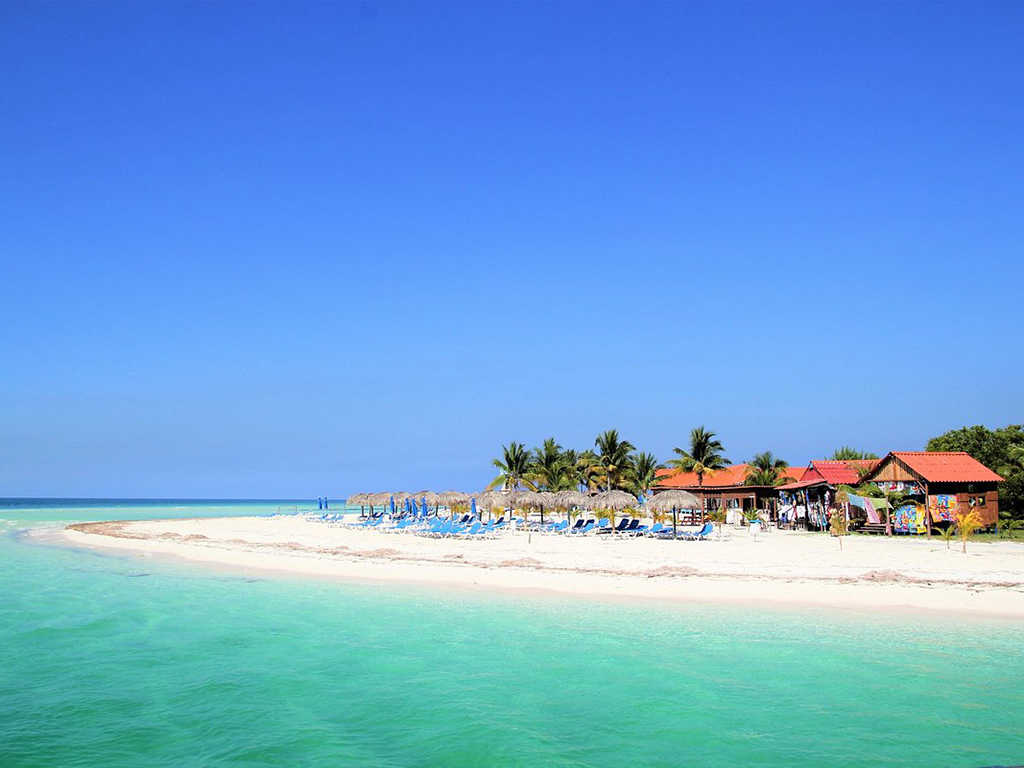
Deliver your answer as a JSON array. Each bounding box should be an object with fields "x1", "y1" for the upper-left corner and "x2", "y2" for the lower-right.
[{"x1": 860, "y1": 451, "x2": 1002, "y2": 530}]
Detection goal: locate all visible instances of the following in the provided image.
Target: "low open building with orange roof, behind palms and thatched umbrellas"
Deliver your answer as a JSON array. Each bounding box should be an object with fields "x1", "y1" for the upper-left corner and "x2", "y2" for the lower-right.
[{"x1": 653, "y1": 464, "x2": 807, "y2": 525}]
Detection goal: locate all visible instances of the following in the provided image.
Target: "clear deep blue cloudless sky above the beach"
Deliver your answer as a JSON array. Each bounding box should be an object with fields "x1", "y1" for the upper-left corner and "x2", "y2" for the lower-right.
[{"x1": 0, "y1": 2, "x2": 1024, "y2": 498}]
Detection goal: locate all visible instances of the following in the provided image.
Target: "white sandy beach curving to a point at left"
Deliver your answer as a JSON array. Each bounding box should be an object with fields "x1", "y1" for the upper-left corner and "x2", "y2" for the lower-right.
[{"x1": 51, "y1": 516, "x2": 1024, "y2": 618}]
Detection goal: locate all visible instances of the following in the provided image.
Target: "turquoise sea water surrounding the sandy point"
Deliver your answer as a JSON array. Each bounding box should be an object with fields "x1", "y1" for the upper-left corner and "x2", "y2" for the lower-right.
[{"x1": 0, "y1": 502, "x2": 1024, "y2": 768}]
